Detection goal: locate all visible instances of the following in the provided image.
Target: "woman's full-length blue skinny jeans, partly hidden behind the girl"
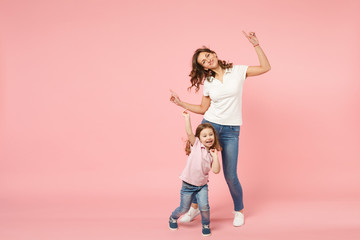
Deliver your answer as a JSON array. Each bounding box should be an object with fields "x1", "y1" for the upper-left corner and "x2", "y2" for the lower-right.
[{"x1": 193, "y1": 119, "x2": 244, "y2": 211}]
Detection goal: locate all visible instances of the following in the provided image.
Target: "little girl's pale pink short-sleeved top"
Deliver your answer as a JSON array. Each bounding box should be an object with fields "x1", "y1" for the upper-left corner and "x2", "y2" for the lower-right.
[{"x1": 180, "y1": 138, "x2": 213, "y2": 186}]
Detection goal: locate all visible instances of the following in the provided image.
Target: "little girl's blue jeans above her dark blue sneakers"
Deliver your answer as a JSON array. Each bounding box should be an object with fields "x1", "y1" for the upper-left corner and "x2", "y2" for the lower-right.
[{"x1": 171, "y1": 181, "x2": 210, "y2": 225}]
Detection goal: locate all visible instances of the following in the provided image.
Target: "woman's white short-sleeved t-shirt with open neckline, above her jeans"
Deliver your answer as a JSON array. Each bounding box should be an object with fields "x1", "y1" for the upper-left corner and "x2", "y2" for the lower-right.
[{"x1": 203, "y1": 65, "x2": 248, "y2": 126}]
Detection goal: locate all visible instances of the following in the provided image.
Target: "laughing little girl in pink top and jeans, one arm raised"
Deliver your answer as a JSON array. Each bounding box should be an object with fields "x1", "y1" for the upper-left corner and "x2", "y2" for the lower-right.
[{"x1": 169, "y1": 110, "x2": 221, "y2": 236}]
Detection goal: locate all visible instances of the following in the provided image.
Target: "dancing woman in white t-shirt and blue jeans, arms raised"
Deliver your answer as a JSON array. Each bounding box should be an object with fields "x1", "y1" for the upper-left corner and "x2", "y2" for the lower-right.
[{"x1": 170, "y1": 31, "x2": 271, "y2": 227}]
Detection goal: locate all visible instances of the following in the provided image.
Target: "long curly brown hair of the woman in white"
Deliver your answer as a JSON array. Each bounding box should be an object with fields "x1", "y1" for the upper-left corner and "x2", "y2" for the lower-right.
[{"x1": 188, "y1": 46, "x2": 233, "y2": 92}]
